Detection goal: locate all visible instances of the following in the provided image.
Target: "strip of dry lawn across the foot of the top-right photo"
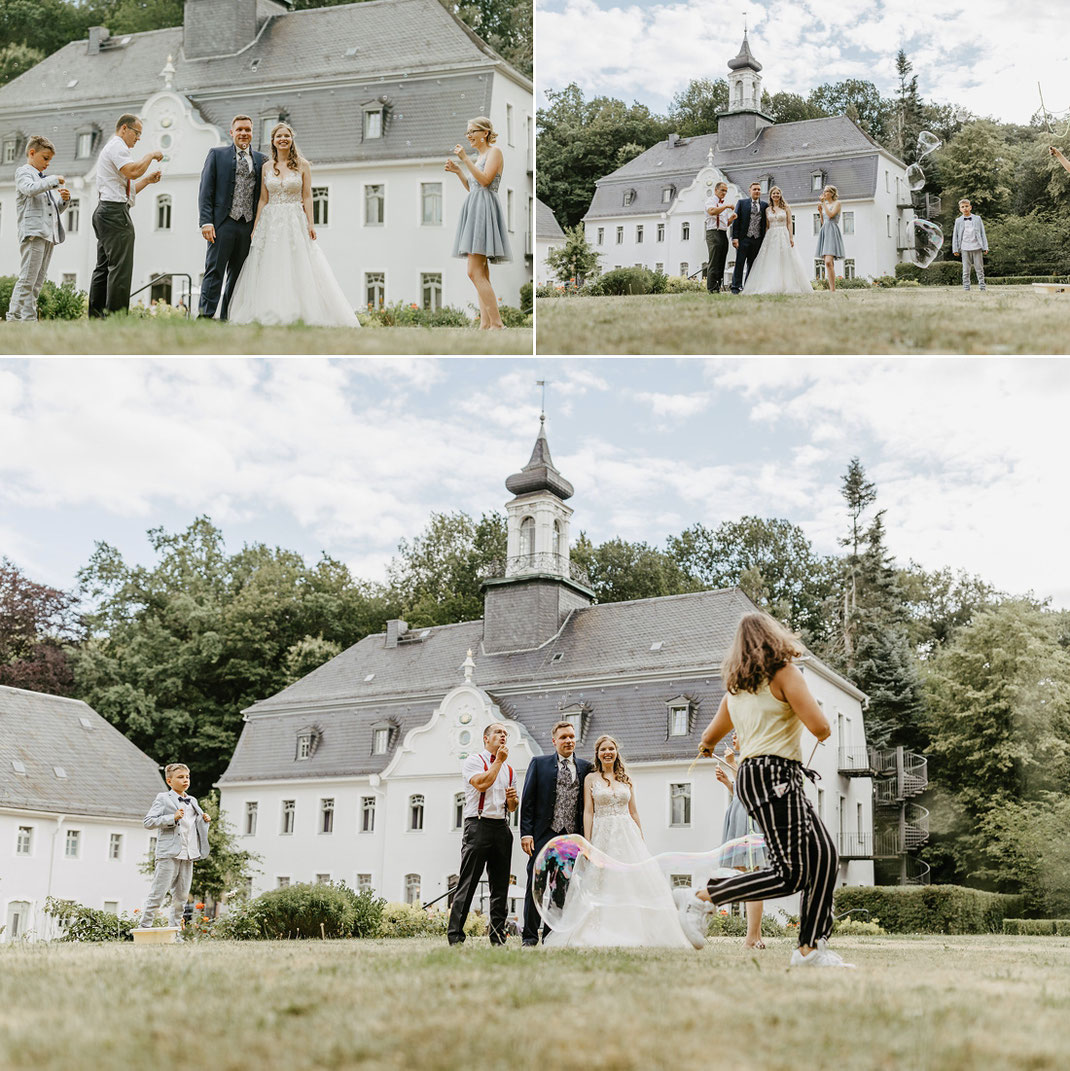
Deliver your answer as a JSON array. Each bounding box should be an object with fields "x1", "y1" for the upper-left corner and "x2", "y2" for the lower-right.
[{"x1": 536, "y1": 286, "x2": 1070, "y2": 355}]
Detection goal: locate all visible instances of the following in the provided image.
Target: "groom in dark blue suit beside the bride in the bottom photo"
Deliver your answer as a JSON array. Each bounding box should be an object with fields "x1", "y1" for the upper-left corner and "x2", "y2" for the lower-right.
[{"x1": 521, "y1": 722, "x2": 593, "y2": 946}]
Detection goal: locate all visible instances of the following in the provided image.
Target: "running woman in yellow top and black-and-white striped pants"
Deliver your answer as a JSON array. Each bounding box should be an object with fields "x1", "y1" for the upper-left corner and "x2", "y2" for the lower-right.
[{"x1": 677, "y1": 613, "x2": 853, "y2": 967}]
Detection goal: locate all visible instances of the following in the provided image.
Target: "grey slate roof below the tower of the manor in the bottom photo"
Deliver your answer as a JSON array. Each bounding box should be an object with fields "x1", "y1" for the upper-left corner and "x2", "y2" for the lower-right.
[{"x1": 220, "y1": 588, "x2": 865, "y2": 784}]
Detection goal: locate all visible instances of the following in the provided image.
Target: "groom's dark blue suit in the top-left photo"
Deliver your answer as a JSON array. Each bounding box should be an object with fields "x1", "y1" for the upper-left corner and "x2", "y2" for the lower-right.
[{"x1": 199, "y1": 145, "x2": 268, "y2": 319}]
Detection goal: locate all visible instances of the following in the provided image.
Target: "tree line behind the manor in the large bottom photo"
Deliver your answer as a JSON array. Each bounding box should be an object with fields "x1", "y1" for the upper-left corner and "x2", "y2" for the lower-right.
[{"x1": 8, "y1": 458, "x2": 1070, "y2": 917}]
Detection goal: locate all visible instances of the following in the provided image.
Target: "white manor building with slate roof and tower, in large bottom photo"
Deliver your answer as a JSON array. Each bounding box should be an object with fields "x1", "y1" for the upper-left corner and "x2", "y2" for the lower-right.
[{"x1": 218, "y1": 417, "x2": 873, "y2": 914}]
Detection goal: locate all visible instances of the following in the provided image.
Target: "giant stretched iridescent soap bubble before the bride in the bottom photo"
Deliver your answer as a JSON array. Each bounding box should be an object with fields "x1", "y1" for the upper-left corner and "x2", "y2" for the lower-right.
[{"x1": 531, "y1": 833, "x2": 765, "y2": 935}]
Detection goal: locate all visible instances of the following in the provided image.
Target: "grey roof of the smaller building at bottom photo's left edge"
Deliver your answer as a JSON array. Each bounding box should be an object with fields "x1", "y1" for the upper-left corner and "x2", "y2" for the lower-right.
[{"x1": 0, "y1": 687, "x2": 166, "y2": 818}]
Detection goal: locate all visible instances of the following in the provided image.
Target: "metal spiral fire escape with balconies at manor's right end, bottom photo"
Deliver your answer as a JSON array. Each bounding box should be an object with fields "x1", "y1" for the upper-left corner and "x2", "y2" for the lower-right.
[{"x1": 840, "y1": 748, "x2": 930, "y2": 885}]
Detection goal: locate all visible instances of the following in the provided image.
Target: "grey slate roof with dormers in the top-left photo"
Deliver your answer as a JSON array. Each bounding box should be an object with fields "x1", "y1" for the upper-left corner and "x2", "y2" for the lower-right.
[{"x1": 0, "y1": 0, "x2": 516, "y2": 181}]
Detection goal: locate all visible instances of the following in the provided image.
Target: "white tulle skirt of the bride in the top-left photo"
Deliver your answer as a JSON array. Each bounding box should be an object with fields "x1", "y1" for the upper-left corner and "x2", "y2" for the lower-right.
[{"x1": 228, "y1": 201, "x2": 360, "y2": 328}]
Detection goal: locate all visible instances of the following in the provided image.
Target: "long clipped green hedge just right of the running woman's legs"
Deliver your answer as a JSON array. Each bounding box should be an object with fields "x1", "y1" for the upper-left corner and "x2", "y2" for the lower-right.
[{"x1": 835, "y1": 885, "x2": 1023, "y2": 934}]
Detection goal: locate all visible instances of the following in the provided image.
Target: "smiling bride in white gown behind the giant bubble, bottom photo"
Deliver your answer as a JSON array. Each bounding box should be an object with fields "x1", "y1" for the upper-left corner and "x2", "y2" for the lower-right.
[{"x1": 543, "y1": 736, "x2": 691, "y2": 948}]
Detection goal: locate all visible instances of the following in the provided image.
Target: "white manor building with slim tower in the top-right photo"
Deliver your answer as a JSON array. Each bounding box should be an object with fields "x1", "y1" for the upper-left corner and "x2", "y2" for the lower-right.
[{"x1": 584, "y1": 34, "x2": 914, "y2": 278}]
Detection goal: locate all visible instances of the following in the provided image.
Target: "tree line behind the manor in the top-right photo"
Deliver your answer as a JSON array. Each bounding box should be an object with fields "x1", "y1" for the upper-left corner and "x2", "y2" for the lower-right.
[{"x1": 536, "y1": 50, "x2": 1070, "y2": 276}]
